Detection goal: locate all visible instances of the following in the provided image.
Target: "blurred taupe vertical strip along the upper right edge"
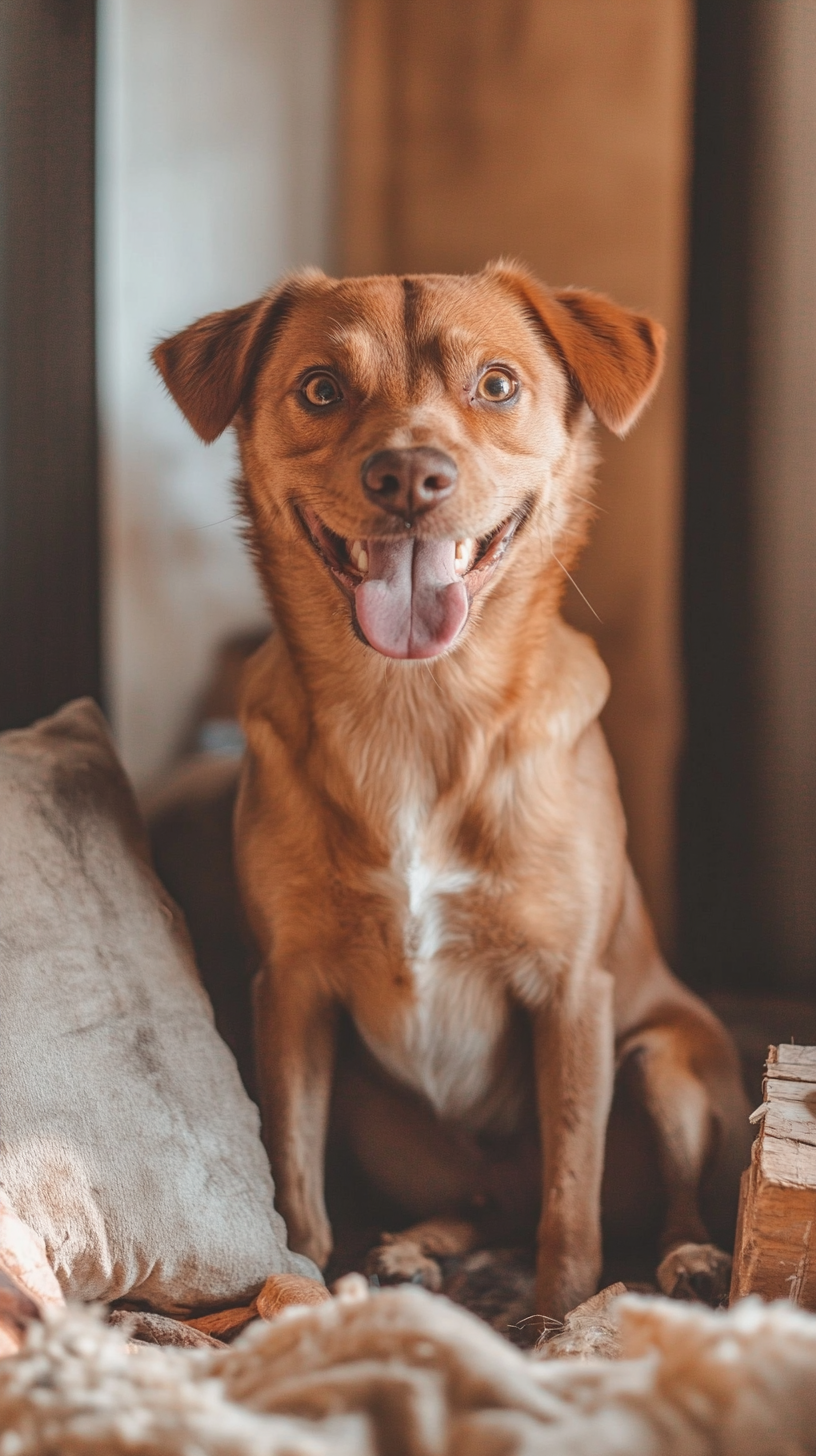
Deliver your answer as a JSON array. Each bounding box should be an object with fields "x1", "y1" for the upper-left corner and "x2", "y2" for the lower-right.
[{"x1": 750, "y1": 0, "x2": 816, "y2": 986}]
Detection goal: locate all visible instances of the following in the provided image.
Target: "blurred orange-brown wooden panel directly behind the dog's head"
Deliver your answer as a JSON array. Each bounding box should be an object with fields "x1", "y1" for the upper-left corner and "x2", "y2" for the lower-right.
[{"x1": 341, "y1": 0, "x2": 692, "y2": 945}]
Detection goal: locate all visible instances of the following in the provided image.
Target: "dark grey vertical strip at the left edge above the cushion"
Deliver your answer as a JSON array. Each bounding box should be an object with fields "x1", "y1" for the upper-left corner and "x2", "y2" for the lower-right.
[{"x1": 0, "y1": 0, "x2": 101, "y2": 729}]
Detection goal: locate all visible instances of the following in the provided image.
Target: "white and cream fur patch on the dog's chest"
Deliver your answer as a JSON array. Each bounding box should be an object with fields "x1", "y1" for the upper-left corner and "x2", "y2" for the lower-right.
[{"x1": 356, "y1": 810, "x2": 510, "y2": 1117}]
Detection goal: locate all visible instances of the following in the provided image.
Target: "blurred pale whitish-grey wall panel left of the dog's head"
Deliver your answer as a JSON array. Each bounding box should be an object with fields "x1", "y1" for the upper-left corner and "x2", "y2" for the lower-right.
[{"x1": 98, "y1": 0, "x2": 335, "y2": 782}]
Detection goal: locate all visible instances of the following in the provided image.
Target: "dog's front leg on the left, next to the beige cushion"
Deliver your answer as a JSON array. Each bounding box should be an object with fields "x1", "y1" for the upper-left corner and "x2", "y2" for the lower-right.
[{"x1": 254, "y1": 965, "x2": 337, "y2": 1268}]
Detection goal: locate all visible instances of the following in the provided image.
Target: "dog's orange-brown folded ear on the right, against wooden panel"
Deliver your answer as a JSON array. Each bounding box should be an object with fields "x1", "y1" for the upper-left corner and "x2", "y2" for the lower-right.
[{"x1": 488, "y1": 262, "x2": 666, "y2": 435}]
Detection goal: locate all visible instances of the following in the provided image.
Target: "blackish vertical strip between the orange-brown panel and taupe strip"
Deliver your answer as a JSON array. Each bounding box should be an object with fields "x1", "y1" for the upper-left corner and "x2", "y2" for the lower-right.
[{"x1": 678, "y1": 0, "x2": 768, "y2": 992}]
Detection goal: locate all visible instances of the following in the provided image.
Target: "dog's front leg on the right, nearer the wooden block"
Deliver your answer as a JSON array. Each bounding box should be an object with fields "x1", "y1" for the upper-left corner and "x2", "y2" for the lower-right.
[{"x1": 533, "y1": 971, "x2": 615, "y2": 1319}]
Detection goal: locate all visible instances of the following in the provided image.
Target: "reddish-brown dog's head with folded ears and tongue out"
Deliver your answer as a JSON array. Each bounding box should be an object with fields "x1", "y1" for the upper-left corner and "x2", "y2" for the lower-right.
[{"x1": 153, "y1": 264, "x2": 663, "y2": 658}]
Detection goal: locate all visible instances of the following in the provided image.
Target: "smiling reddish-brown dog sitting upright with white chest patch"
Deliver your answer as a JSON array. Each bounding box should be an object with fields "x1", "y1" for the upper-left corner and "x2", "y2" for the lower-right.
[{"x1": 154, "y1": 264, "x2": 748, "y2": 1316}]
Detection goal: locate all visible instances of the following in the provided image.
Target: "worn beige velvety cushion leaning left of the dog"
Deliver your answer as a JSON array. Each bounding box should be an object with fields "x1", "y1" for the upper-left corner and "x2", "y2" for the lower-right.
[{"x1": 0, "y1": 700, "x2": 319, "y2": 1312}]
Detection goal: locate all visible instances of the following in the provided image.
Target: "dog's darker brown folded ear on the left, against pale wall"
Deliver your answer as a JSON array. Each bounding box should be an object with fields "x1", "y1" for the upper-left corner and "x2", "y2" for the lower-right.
[{"x1": 150, "y1": 269, "x2": 322, "y2": 444}]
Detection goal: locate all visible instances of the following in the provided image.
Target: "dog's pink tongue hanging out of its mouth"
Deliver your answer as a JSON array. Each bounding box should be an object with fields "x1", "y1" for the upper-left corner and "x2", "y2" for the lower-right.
[{"x1": 354, "y1": 537, "x2": 468, "y2": 657}]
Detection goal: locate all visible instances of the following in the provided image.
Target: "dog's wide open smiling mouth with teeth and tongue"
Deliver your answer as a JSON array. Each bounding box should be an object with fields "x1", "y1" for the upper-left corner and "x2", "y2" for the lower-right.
[{"x1": 299, "y1": 507, "x2": 527, "y2": 658}]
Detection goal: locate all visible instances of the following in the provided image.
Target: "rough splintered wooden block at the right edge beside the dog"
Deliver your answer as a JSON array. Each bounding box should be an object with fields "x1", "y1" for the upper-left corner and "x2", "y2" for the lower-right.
[{"x1": 730, "y1": 1045, "x2": 816, "y2": 1310}]
